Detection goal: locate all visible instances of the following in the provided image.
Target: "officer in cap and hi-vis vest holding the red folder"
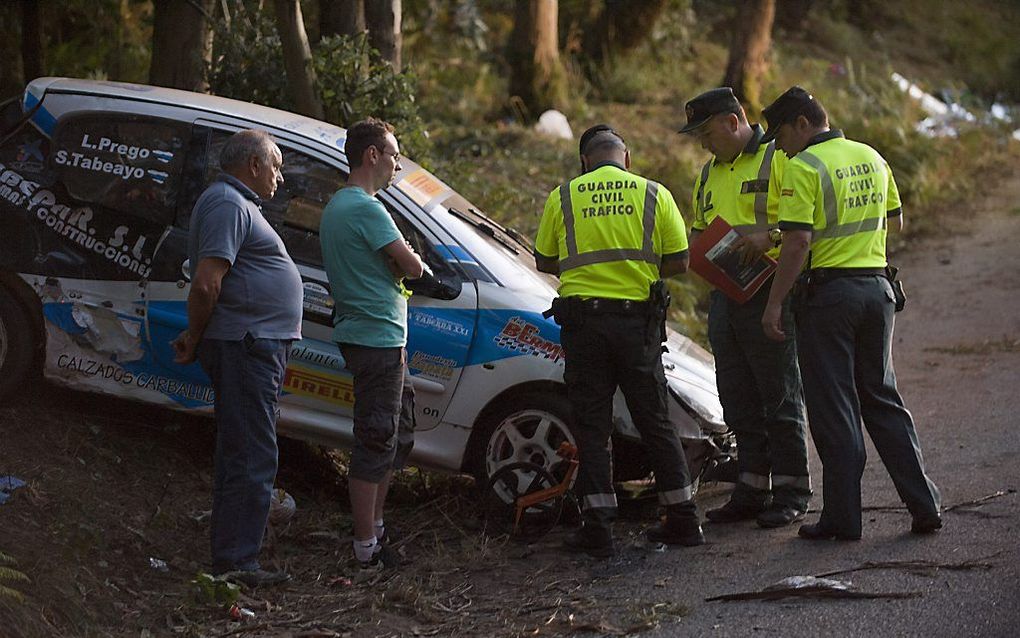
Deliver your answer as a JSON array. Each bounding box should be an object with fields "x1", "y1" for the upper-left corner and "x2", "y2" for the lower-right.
[{"x1": 680, "y1": 87, "x2": 811, "y2": 528}]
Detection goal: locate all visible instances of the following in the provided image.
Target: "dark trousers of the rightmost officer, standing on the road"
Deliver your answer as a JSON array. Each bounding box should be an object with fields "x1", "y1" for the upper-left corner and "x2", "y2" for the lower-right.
[{"x1": 796, "y1": 276, "x2": 940, "y2": 535}]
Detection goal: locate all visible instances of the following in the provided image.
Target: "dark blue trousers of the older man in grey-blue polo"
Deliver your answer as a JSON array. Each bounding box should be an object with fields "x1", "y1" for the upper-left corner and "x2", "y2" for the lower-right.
[{"x1": 198, "y1": 336, "x2": 291, "y2": 574}]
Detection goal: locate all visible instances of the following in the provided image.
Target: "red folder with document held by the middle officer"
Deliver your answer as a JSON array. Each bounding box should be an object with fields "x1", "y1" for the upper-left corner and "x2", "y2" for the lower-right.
[{"x1": 691, "y1": 216, "x2": 775, "y2": 303}]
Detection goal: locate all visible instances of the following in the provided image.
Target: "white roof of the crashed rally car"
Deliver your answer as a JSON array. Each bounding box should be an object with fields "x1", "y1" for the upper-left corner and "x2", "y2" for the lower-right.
[{"x1": 27, "y1": 78, "x2": 347, "y2": 149}]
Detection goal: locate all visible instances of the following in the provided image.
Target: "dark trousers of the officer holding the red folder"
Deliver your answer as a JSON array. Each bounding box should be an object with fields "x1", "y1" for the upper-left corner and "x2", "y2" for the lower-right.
[{"x1": 708, "y1": 284, "x2": 811, "y2": 510}]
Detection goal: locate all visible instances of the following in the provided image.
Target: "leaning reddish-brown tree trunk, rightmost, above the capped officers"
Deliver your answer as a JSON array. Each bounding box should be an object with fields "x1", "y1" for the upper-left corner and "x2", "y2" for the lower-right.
[{"x1": 722, "y1": 0, "x2": 775, "y2": 111}]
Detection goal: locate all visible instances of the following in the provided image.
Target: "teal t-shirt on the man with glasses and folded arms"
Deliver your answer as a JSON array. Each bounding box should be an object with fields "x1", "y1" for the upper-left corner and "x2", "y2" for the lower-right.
[{"x1": 319, "y1": 186, "x2": 407, "y2": 348}]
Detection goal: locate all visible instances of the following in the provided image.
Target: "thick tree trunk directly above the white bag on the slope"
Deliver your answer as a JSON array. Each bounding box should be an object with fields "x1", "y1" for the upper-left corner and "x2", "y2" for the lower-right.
[{"x1": 507, "y1": 0, "x2": 566, "y2": 120}]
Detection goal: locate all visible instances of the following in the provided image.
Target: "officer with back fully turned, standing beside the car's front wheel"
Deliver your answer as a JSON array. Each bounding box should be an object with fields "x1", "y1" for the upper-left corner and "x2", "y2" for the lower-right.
[{"x1": 534, "y1": 125, "x2": 705, "y2": 557}]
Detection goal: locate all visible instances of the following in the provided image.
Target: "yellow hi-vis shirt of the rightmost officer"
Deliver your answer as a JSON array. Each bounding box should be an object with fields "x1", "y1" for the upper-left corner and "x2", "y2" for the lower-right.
[{"x1": 779, "y1": 131, "x2": 901, "y2": 268}]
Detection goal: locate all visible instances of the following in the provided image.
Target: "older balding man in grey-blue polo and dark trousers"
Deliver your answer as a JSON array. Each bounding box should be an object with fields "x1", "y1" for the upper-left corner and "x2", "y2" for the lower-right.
[{"x1": 173, "y1": 131, "x2": 302, "y2": 587}]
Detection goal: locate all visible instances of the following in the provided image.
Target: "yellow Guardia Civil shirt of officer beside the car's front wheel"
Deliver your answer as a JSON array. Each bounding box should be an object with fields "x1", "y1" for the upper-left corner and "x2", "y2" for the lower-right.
[{"x1": 534, "y1": 162, "x2": 687, "y2": 301}]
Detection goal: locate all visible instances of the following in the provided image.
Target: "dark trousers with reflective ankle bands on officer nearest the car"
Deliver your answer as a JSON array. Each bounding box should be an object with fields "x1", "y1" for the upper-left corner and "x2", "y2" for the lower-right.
[{"x1": 560, "y1": 312, "x2": 697, "y2": 528}]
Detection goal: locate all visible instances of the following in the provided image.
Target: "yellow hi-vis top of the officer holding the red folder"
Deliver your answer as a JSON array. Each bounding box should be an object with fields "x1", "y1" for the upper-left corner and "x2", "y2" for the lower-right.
[{"x1": 691, "y1": 125, "x2": 787, "y2": 257}]
